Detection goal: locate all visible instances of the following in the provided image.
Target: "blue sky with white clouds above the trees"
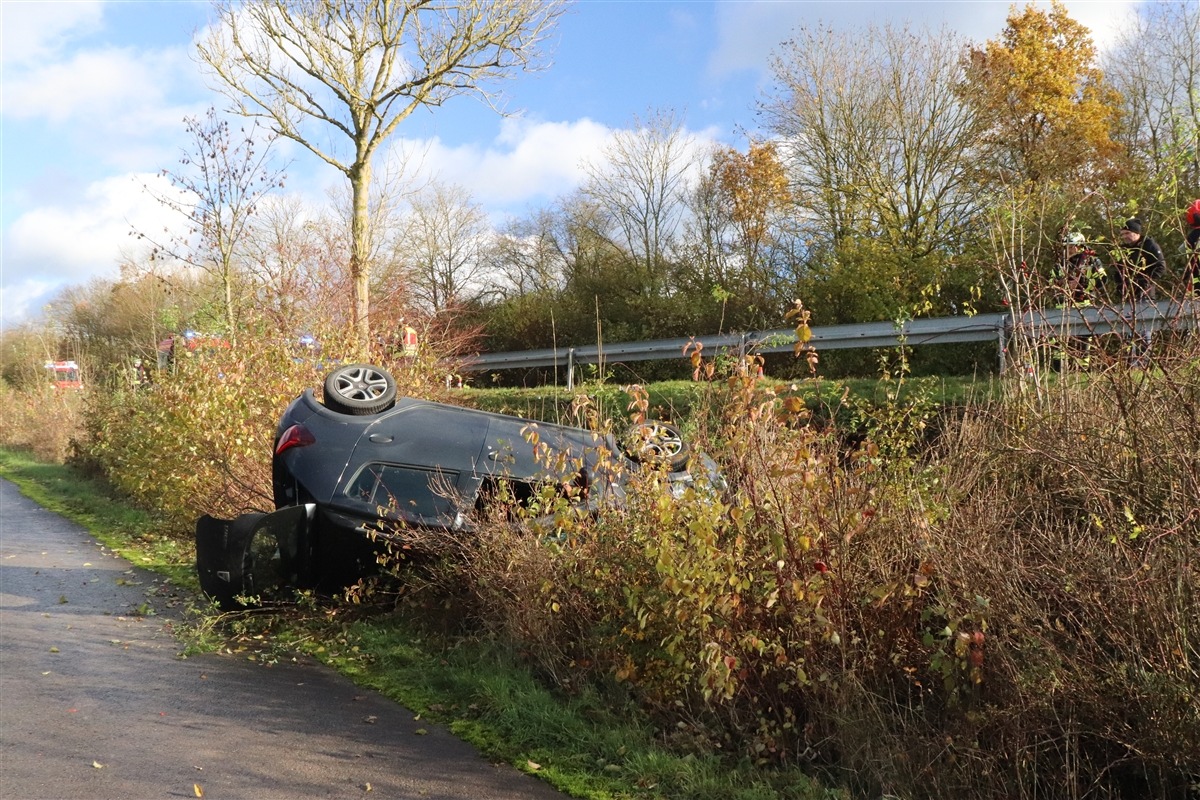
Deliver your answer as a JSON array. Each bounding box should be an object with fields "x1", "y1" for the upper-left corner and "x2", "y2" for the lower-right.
[{"x1": 0, "y1": 0, "x2": 1132, "y2": 326}]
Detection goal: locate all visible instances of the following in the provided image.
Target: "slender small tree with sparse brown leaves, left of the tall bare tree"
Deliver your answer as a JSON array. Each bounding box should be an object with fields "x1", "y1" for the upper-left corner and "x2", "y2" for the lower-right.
[{"x1": 136, "y1": 108, "x2": 283, "y2": 342}]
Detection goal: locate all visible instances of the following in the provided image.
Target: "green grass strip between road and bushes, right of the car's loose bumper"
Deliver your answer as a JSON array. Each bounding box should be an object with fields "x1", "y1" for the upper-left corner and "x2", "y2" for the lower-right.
[{"x1": 314, "y1": 616, "x2": 845, "y2": 800}]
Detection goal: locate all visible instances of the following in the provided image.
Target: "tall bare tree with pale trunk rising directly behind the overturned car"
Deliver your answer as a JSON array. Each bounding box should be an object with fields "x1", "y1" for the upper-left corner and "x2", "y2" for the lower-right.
[{"x1": 198, "y1": 0, "x2": 562, "y2": 350}]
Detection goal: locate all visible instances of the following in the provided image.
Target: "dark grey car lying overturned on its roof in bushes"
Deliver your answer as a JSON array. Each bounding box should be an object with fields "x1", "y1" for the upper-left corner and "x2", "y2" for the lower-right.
[{"x1": 196, "y1": 365, "x2": 720, "y2": 607}]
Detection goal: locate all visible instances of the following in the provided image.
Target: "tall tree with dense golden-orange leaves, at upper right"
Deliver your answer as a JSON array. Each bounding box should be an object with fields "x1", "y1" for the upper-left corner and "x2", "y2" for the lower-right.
[{"x1": 961, "y1": 0, "x2": 1121, "y2": 185}]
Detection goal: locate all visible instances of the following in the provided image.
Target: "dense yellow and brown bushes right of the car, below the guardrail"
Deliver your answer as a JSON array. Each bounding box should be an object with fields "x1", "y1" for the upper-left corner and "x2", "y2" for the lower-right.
[{"x1": 405, "y1": 342, "x2": 1200, "y2": 799}]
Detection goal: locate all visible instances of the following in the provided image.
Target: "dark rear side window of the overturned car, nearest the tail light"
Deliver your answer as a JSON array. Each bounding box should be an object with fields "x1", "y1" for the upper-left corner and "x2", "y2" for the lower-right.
[{"x1": 346, "y1": 464, "x2": 458, "y2": 522}]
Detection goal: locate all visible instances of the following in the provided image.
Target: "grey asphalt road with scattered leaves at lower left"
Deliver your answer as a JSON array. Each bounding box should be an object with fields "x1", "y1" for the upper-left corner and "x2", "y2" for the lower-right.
[{"x1": 0, "y1": 480, "x2": 565, "y2": 800}]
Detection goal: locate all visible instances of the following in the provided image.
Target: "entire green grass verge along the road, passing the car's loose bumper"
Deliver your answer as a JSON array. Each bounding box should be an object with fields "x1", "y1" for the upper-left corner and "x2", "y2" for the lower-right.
[{"x1": 0, "y1": 450, "x2": 846, "y2": 800}]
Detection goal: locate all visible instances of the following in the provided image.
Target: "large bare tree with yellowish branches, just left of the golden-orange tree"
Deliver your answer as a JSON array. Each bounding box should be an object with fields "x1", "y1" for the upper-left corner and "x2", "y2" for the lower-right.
[{"x1": 760, "y1": 26, "x2": 978, "y2": 254}]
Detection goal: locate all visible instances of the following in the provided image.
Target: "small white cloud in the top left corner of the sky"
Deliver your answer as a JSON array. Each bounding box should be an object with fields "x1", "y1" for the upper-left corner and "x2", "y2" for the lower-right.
[{"x1": 0, "y1": 0, "x2": 103, "y2": 67}]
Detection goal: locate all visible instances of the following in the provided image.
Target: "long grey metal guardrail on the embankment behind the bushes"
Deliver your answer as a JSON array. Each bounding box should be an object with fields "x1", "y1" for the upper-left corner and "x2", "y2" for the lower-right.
[{"x1": 462, "y1": 299, "x2": 1200, "y2": 374}]
